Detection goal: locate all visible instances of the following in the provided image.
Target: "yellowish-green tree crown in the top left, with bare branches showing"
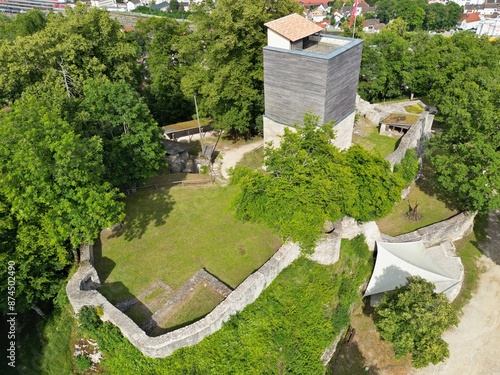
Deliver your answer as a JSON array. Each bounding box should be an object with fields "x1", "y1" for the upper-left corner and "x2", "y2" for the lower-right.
[{"x1": 0, "y1": 3, "x2": 141, "y2": 102}]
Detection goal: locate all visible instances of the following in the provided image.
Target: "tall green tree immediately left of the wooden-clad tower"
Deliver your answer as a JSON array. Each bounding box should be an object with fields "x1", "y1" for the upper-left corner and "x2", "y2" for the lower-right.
[{"x1": 178, "y1": 0, "x2": 301, "y2": 136}]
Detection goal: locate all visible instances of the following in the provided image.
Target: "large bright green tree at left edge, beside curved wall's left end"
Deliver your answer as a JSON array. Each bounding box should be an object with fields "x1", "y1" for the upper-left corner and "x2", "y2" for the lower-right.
[{"x1": 0, "y1": 92, "x2": 123, "y2": 312}]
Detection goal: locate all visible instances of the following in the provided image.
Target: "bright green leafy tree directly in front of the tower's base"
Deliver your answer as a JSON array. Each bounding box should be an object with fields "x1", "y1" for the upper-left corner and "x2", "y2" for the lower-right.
[{"x1": 232, "y1": 114, "x2": 402, "y2": 251}]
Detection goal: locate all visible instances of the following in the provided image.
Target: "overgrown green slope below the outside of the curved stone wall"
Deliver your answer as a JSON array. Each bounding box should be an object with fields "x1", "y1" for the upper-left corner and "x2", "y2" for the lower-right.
[{"x1": 73, "y1": 237, "x2": 372, "y2": 375}]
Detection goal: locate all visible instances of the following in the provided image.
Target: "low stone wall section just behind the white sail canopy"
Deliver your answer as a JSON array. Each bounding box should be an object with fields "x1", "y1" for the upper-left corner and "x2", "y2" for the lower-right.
[{"x1": 382, "y1": 212, "x2": 476, "y2": 247}]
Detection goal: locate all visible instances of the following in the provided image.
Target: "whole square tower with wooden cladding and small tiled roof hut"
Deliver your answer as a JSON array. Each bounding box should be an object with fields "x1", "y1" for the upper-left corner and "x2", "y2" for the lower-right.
[{"x1": 264, "y1": 14, "x2": 363, "y2": 149}]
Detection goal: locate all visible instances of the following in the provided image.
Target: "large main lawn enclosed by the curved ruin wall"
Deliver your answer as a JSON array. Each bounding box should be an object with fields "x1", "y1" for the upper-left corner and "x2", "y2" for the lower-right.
[{"x1": 96, "y1": 186, "x2": 281, "y2": 302}]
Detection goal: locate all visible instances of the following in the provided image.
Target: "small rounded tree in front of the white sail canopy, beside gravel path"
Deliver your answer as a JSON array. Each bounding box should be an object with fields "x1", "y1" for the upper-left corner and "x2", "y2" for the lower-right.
[{"x1": 375, "y1": 276, "x2": 458, "y2": 368}]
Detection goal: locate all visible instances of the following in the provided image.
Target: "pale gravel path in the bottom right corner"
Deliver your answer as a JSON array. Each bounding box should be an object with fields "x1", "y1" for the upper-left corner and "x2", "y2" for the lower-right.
[{"x1": 412, "y1": 211, "x2": 500, "y2": 375}]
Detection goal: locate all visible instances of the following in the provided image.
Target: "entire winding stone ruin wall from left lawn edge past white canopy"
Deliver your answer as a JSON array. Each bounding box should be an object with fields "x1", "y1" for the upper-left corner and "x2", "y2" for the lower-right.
[{"x1": 66, "y1": 213, "x2": 475, "y2": 358}]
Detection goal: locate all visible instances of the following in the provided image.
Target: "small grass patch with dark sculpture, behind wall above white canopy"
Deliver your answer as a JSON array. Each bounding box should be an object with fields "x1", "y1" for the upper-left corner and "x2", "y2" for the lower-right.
[{"x1": 377, "y1": 185, "x2": 458, "y2": 236}]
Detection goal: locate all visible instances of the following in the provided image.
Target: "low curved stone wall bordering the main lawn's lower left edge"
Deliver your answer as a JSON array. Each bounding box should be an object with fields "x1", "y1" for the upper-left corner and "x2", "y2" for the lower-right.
[{"x1": 66, "y1": 244, "x2": 300, "y2": 358}]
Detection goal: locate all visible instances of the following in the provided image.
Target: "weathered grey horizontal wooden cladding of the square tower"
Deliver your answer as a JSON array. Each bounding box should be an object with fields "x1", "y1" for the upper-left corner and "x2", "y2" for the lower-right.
[{"x1": 264, "y1": 37, "x2": 363, "y2": 125}]
